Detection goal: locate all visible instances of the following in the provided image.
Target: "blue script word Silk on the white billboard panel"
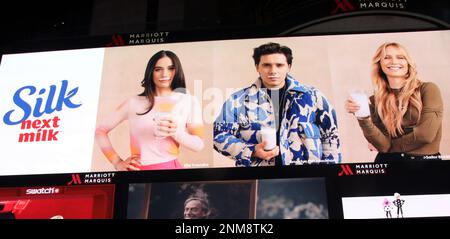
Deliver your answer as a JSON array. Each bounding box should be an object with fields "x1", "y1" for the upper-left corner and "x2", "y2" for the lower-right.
[{"x1": 3, "y1": 80, "x2": 81, "y2": 125}]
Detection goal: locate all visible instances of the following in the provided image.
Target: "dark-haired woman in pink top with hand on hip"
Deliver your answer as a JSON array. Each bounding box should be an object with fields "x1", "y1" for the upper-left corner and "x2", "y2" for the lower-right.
[{"x1": 96, "y1": 51, "x2": 204, "y2": 171}]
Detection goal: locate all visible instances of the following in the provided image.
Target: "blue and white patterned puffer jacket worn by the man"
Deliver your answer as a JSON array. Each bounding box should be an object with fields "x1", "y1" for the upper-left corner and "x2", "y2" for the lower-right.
[{"x1": 214, "y1": 75, "x2": 341, "y2": 166}]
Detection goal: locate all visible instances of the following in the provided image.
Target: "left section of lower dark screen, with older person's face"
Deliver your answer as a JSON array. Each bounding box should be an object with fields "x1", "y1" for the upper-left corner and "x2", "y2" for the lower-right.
[{"x1": 128, "y1": 180, "x2": 256, "y2": 219}]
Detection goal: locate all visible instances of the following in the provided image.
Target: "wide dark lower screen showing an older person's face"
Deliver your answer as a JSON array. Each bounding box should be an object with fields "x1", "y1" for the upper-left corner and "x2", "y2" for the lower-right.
[{"x1": 127, "y1": 178, "x2": 328, "y2": 219}]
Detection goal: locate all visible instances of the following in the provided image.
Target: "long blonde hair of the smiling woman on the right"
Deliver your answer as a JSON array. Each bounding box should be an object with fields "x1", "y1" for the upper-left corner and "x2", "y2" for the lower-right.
[{"x1": 372, "y1": 42, "x2": 422, "y2": 137}]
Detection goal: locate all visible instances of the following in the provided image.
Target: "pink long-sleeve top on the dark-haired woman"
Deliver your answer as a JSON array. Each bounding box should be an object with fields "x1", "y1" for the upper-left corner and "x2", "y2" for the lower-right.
[{"x1": 96, "y1": 92, "x2": 204, "y2": 166}]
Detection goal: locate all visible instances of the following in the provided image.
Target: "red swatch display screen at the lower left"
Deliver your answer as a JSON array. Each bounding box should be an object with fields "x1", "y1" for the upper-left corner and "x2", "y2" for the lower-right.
[{"x1": 0, "y1": 185, "x2": 114, "y2": 219}]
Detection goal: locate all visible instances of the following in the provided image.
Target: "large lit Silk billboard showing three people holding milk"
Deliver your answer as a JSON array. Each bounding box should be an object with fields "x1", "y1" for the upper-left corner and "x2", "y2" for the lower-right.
[{"x1": 0, "y1": 31, "x2": 450, "y2": 175}]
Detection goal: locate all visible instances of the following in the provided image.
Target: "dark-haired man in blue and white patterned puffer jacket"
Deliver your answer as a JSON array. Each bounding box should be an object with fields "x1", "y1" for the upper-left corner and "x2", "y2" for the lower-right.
[{"x1": 214, "y1": 43, "x2": 341, "y2": 166}]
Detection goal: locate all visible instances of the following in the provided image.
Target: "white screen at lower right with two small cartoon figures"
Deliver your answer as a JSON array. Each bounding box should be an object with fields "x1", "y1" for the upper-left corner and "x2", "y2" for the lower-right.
[{"x1": 342, "y1": 194, "x2": 450, "y2": 219}]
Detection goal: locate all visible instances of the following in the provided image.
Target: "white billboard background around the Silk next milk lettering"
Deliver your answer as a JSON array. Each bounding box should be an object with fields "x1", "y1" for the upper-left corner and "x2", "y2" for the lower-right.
[{"x1": 0, "y1": 49, "x2": 104, "y2": 175}]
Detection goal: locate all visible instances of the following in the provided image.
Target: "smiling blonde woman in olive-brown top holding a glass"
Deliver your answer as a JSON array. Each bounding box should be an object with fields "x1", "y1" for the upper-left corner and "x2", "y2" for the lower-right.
[{"x1": 346, "y1": 43, "x2": 443, "y2": 163}]
